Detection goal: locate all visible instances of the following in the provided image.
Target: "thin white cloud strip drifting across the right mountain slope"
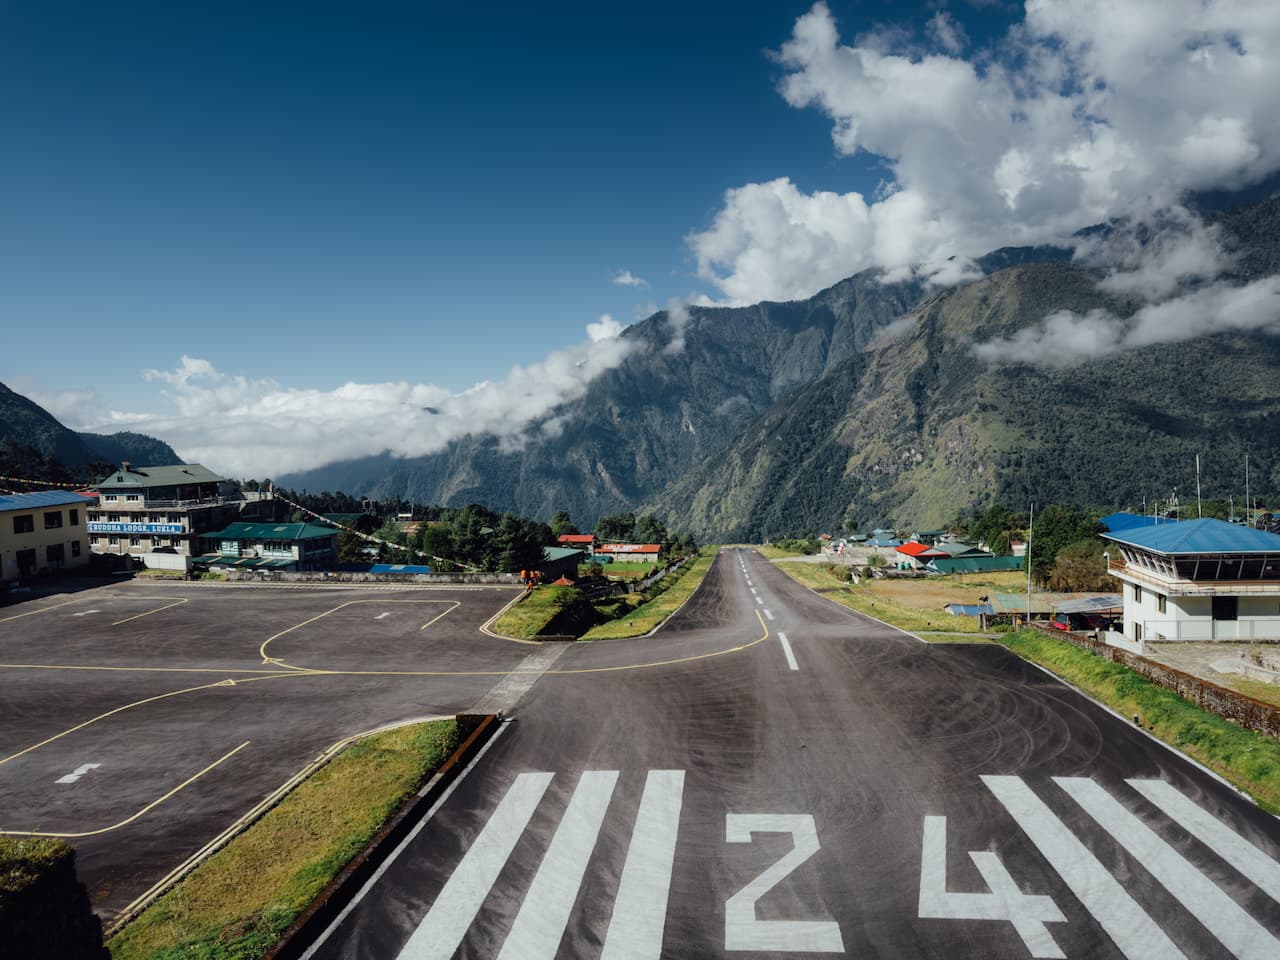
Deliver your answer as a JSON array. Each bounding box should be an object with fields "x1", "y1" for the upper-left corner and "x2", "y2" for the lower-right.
[{"x1": 973, "y1": 276, "x2": 1280, "y2": 367}]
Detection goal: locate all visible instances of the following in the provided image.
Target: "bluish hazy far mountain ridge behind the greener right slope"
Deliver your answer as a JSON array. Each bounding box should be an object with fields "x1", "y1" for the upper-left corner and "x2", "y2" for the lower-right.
[{"x1": 276, "y1": 271, "x2": 920, "y2": 524}]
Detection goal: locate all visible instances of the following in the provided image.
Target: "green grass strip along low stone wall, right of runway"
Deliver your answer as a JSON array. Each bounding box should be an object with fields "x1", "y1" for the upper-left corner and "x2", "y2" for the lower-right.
[{"x1": 1000, "y1": 630, "x2": 1280, "y2": 813}]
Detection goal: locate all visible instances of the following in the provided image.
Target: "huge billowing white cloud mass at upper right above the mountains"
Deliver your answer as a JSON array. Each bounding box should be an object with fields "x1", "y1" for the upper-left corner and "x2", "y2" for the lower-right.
[{"x1": 687, "y1": 0, "x2": 1280, "y2": 303}]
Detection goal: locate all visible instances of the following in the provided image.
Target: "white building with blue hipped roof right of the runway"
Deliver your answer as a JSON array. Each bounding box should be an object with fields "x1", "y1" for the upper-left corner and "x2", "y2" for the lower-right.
[{"x1": 1103, "y1": 520, "x2": 1280, "y2": 645}]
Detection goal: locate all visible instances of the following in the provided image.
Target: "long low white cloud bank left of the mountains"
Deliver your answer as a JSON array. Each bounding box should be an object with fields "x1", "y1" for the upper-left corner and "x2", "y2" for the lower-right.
[{"x1": 77, "y1": 315, "x2": 634, "y2": 477}]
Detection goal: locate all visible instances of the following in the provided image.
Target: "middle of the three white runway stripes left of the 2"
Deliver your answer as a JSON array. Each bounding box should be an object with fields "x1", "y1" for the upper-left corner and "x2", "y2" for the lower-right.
[{"x1": 498, "y1": 771, "x2": 618, "y2": 960}]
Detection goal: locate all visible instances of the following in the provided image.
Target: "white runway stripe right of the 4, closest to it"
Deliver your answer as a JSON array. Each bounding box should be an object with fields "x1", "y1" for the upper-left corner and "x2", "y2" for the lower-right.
[{"x1": 982, "y1": 776, "x2": 1185, "y2": 960}]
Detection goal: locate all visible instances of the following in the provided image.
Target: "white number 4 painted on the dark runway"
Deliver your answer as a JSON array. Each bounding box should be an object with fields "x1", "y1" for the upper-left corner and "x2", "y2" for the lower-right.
[{"x1": 920, "y1": 817, "x2": 1066, "y2": 957}]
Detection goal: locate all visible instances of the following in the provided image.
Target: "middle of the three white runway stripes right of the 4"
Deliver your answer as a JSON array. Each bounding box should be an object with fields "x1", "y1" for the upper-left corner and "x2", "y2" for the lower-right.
[{"x1": 1053, "y1": 777, "x2": 1280, "y2": 960}]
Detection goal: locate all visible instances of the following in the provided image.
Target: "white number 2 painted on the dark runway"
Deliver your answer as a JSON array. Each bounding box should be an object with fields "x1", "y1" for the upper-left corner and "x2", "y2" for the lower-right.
[{"x1": 724, "y1": 813, "x2": 845, "y2": 954}]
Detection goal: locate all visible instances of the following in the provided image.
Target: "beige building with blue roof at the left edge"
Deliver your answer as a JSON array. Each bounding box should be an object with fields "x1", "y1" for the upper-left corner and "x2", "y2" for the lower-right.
[{"x1": 0, "y1": 490, "x2": 93, "y2": 581}]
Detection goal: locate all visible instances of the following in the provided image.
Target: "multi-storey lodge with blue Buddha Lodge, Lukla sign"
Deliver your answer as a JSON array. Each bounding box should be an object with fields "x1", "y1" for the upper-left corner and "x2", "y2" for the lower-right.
[{"x1": 87, "y1": 463, "x2": 243, "y2": 557}]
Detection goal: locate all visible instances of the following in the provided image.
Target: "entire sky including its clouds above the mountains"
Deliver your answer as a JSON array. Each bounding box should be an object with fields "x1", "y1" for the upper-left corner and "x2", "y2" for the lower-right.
[{"x1": 0, "y1": 0, "x2": 1280, "y2": 472}]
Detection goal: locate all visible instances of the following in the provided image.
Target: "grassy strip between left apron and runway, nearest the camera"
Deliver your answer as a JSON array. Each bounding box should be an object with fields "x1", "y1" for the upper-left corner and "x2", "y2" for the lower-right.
[{"x1": 108, "y1": 719, "x2": 458, "y2": 960}]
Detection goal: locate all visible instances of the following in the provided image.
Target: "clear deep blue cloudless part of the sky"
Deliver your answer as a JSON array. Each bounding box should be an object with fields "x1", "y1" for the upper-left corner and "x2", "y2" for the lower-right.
[{"x1": 0, "y1": 3, "x2": 1013, "y2": 408}]
